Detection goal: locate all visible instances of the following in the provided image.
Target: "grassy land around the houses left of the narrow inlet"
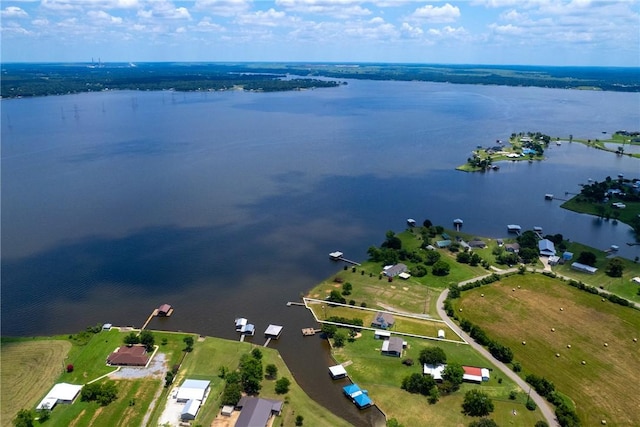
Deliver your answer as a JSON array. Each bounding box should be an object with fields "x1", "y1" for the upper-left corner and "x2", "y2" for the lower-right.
[{"x1": 1, "y1": 329, "x2": 349, "y2": 427}]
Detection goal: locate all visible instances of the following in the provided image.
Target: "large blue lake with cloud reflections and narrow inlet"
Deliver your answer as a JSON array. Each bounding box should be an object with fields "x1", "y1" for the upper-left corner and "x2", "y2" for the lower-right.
[{"x1": 0, "y1": 81, "x2": 640, "y2": 425}]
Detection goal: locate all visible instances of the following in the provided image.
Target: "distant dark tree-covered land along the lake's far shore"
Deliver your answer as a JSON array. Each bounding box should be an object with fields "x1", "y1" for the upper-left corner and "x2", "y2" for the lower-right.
[{"x1": 1, "y1": 62, "x2": 640, "y2": 98}]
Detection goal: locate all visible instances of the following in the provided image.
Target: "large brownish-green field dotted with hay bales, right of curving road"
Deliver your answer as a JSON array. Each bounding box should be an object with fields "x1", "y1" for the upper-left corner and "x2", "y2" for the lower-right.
[{"x1": 454, "y1": 274, "x2": 640, "y2": 426}]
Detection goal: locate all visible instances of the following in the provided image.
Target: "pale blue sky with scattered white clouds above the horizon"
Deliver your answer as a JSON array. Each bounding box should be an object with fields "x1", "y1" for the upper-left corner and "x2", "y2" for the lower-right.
[{"x1": 0, "y1": 0, "x2": 640, "y2": 67}]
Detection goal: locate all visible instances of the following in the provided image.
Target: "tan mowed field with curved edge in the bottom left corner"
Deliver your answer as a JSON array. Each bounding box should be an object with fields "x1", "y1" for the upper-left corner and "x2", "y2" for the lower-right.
[{"x1": 0, "y1": 340, "x2": 71, "y2": 427}]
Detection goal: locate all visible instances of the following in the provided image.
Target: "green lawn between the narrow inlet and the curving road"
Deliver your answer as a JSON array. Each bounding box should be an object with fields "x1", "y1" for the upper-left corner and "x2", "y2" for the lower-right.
[{"x1": 333, "y1": 331, "x2": 542, "y2": 426}]
